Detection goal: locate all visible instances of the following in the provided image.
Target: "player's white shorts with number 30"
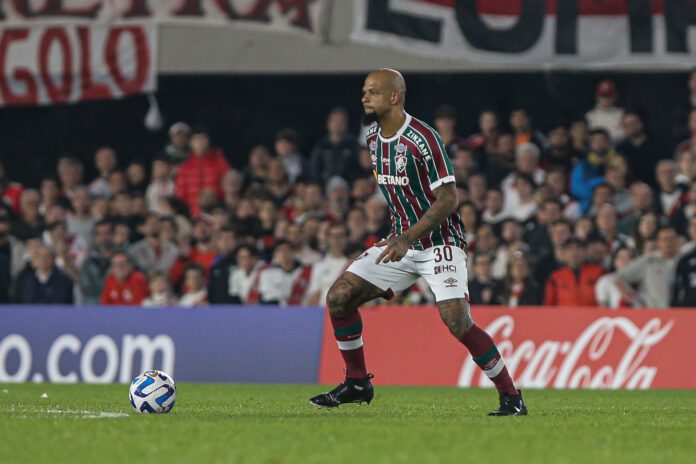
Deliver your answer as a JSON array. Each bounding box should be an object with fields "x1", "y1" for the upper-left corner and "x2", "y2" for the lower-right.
[{"x1": 347, "y1": 245, "x2": 469, "y2": 301}]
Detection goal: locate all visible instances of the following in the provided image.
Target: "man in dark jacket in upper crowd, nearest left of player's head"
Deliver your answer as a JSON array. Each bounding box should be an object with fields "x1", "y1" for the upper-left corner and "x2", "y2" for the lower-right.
[{"x1": 310, "y1": 108, "x2": 361, "y2": 185}]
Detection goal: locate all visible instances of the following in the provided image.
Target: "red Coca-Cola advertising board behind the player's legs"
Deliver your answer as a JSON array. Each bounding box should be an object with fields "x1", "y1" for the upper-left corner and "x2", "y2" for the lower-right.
[{"x1": 319, "y1": 307, "x2": 696, "y2": 389}]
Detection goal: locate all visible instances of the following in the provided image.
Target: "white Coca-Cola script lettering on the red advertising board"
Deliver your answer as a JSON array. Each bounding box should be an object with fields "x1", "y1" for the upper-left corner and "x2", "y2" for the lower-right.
[{"x1": 458, "y1": 315, "x2": 674, "y2": 389}]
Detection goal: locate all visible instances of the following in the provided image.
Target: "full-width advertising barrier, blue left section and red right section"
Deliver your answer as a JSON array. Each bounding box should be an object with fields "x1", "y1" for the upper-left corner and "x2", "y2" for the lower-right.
[{"x1": 0, "y1": 306, "x2": 696, "y2": 389}]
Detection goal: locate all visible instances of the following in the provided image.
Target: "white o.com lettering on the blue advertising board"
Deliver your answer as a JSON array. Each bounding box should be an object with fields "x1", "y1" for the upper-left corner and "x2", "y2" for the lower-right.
[{"x1": 0, "y1": 334, "x2": 176, "y2": 383}]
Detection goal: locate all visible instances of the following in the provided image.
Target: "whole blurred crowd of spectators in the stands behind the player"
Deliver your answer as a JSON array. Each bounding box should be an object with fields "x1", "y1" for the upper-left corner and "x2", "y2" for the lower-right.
[{"x1": 0, "y1": 72, "x2": 696, "y2": 308}]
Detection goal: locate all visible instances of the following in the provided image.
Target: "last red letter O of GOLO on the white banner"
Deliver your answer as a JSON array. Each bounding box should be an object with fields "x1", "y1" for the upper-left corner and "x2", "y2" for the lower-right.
[{"x1": 105, "y1": 27, "x2": 150, "y2": 95}]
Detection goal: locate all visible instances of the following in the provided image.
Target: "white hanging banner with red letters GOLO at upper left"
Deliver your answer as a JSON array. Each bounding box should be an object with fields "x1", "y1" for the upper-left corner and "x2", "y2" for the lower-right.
[{"x1": 0, "y1": 25, "x2": 157, "y2": 107}]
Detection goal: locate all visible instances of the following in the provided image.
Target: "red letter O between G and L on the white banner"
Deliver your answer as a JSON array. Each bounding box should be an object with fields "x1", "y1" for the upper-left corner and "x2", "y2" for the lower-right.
[{"x1": 39, "y1": 27, "x2": 73, "y2": 103}]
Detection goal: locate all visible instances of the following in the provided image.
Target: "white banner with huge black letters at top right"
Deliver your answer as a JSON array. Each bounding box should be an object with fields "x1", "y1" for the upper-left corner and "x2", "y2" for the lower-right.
[{"x1": 351, "y1": 0, "x2": 696, "y2": 70}]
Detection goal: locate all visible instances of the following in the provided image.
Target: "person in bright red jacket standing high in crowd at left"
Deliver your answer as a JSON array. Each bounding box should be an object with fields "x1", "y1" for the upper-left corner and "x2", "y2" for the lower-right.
[{"x1": 175, "y1": 127, "x2": 230, "y2": 216}]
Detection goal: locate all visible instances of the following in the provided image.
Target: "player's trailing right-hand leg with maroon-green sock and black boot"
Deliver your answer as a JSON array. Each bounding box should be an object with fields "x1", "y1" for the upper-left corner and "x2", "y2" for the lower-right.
[{"x1": 437, "y1": 298, "x2": 527, "y2": 416}]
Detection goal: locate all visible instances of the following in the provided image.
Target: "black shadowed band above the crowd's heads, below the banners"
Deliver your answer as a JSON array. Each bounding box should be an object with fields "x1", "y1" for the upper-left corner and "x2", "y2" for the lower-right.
[{"x1": 0, "y1": 72, "x2": 688, "y2": 186}]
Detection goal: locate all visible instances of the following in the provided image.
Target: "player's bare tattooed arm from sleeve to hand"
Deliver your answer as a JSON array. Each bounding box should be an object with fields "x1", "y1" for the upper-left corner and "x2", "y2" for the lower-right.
[{"x1": 375, "y1": 182, "x2": 457, "y2": 264}]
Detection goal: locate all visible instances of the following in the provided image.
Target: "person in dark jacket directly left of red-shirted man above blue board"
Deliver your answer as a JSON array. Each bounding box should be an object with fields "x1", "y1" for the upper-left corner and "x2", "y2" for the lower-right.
[{"x1": 79, "y1": 220, "x2": 114, "y2": 305}]
